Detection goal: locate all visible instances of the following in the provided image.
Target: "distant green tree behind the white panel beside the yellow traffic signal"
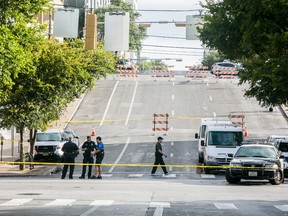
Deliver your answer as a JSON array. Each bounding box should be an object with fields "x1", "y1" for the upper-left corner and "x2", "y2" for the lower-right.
[{"x1": 95, "y1": 0, "x2": 146, "y2": 51}]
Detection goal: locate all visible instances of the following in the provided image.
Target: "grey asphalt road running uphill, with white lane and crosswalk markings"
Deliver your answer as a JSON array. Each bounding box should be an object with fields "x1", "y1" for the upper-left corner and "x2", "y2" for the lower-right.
[{"x1": 0, "y1": 72, "x2": 288, "y2": 216}]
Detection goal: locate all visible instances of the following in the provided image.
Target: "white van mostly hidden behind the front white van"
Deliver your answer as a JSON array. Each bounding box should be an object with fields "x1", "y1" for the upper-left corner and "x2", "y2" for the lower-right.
[{"x1": 195, "y1": 118, "x2": 230, "y2": 163}]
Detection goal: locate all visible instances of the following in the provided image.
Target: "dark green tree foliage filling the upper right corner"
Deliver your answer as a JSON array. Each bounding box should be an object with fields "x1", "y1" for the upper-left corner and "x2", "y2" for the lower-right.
[{"x1": 198, "y1": 0, "x2": 288, "y2": 106}]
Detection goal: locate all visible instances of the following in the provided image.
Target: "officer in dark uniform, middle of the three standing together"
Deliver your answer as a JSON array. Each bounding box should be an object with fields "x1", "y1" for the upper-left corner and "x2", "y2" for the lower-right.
[{"x1": 79, "y1": 136, "x2": 96, "y2": 179}]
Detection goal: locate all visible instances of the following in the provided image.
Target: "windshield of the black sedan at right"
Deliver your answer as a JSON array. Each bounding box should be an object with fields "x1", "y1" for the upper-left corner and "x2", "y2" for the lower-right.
[{"x1": 235, "y1": 146, "x2": 277, "y2": 159}]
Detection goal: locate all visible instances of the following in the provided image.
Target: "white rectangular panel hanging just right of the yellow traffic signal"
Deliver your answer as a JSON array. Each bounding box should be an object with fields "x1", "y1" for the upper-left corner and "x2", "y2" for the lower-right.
[{"x1": 104, "y1": 12, "x2": 130, "y2": 51}]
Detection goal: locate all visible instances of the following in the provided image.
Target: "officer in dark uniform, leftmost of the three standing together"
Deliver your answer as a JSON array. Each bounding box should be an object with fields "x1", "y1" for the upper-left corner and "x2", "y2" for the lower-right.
[{"x1": 61, "y1": 137, "x2": 79, "y2": 179}]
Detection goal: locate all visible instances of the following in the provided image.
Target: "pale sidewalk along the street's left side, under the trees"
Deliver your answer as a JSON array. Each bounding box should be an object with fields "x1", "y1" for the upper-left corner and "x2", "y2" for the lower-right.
[{"x1": 0, "y1": 95, "x2": 85, "y2": 177}]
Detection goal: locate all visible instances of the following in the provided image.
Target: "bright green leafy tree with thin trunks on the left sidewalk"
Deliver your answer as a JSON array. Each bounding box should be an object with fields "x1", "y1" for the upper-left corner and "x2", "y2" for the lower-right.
[{"x1": 0, "y1": 0, "x2": 116, "y2": 166}]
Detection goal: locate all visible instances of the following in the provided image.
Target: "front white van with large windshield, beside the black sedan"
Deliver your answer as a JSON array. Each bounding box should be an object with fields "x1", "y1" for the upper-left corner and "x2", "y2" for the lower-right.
[{"x1": 201, "y1": 121, "x2": 244, "y2": 174}]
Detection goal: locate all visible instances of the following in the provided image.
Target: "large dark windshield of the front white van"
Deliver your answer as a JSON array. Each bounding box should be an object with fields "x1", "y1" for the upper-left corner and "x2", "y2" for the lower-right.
[{"x1": 208, "y1": 131, "x2": 243, "y2": 146}]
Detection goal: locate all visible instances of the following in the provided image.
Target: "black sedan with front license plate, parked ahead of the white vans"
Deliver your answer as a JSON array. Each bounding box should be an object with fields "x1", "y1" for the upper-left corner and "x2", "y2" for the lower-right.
[{"x1": 226, "y1": 144, "x2": 284, "y2": 185}]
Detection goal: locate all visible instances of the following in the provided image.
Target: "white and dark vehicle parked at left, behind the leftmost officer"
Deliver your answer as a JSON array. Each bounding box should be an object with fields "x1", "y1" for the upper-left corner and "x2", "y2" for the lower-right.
[{"x1": 34, "y1": 130, "x2": 68, "y2": 161}]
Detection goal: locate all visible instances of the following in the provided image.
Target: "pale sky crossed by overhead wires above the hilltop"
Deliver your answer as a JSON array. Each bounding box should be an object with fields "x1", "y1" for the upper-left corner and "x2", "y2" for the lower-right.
[{"x1": 137, "y1": 0, "x2": 204, "y2": 69}]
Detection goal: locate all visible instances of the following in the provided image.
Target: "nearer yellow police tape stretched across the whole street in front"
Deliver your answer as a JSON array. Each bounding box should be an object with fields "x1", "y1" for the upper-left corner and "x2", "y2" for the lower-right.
[{"x1": 0, "y1": 161, "x2": 287, "y2": 170}]
